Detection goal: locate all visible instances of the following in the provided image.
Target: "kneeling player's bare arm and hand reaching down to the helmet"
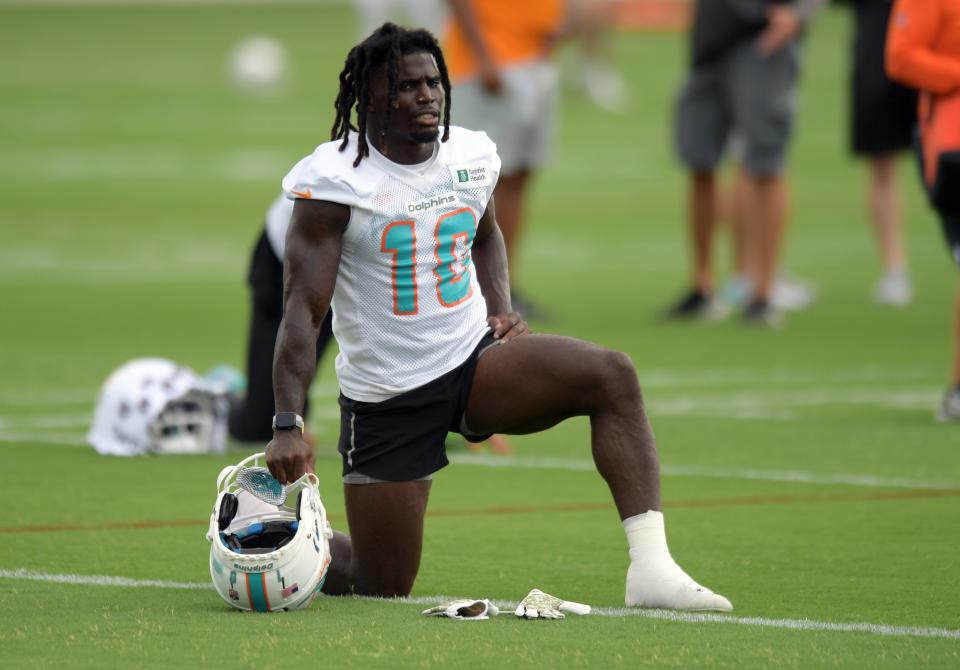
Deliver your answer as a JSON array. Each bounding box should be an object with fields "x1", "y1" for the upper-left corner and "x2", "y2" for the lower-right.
[{"x1": 267, "y1": 200, "x2": 350, "y2": 483}]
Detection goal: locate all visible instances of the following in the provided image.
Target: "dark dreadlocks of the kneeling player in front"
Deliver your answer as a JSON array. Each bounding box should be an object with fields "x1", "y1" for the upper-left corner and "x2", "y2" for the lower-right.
[{"x1": 330, "y1": 23, "x2": 450, "y2": 167}]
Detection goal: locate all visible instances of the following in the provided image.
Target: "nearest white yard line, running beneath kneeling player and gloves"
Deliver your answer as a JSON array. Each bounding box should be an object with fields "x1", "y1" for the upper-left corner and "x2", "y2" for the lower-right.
[{"x1": 0, "y1": 569, "x2": 960, "y2": 640}]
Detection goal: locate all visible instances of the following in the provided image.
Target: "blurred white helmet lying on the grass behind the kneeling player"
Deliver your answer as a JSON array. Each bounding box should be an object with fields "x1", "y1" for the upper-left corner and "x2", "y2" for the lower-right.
[{"x1": 87, "y1": 358, "x2": 228, "y2": 456}]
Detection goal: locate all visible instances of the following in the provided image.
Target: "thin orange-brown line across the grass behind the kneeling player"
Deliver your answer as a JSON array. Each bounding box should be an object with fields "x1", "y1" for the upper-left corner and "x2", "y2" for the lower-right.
[{"x1": 0, "y1": 490, "x2": 960, "y2": 534}]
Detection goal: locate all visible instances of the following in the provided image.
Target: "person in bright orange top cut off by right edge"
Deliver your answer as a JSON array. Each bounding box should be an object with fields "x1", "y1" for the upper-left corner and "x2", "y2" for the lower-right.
[{"x1": 886, "y1": 0, "x2": 960, "y2": 421}]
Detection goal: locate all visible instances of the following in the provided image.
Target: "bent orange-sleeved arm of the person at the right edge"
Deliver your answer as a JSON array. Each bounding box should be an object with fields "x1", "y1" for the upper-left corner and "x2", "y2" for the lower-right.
[{"x1": 886, "y1": 0, "x2": 960, "y2": 94}]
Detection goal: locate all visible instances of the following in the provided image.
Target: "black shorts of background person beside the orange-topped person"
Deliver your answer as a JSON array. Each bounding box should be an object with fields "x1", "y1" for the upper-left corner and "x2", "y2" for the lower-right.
[{"x1": 850, "y1": 0, "x2": 917, "y2": 156}]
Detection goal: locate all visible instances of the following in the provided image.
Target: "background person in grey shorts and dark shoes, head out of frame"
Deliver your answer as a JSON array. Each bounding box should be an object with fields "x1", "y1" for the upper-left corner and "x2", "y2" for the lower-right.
[{"x1": 667, "y1": 0, "x2": 822, "y2": 325}]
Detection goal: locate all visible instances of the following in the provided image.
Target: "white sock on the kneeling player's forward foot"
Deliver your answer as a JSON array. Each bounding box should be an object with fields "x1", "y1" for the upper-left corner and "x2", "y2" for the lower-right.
[{"x1": 623, "y1": 510, "x2": 733, "y2": 611}]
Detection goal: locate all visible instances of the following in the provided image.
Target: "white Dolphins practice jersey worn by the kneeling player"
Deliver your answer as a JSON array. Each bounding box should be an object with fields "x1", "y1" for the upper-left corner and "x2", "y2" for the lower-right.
[{"x1": 283, "y1": 127, "x2": 500, "y2": 402}]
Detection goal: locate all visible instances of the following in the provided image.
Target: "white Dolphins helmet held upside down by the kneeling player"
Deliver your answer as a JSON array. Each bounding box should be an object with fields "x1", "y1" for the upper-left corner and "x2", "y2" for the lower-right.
[{"x1": 207, "y1": 453, "x2": 333, "y2": 612}]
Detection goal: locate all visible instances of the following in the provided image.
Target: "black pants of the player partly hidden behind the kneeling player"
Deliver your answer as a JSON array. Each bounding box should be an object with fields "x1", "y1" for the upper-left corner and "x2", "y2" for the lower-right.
[{"x1": 229, "y1": 231, "x2": 332, "y2": 444}]
